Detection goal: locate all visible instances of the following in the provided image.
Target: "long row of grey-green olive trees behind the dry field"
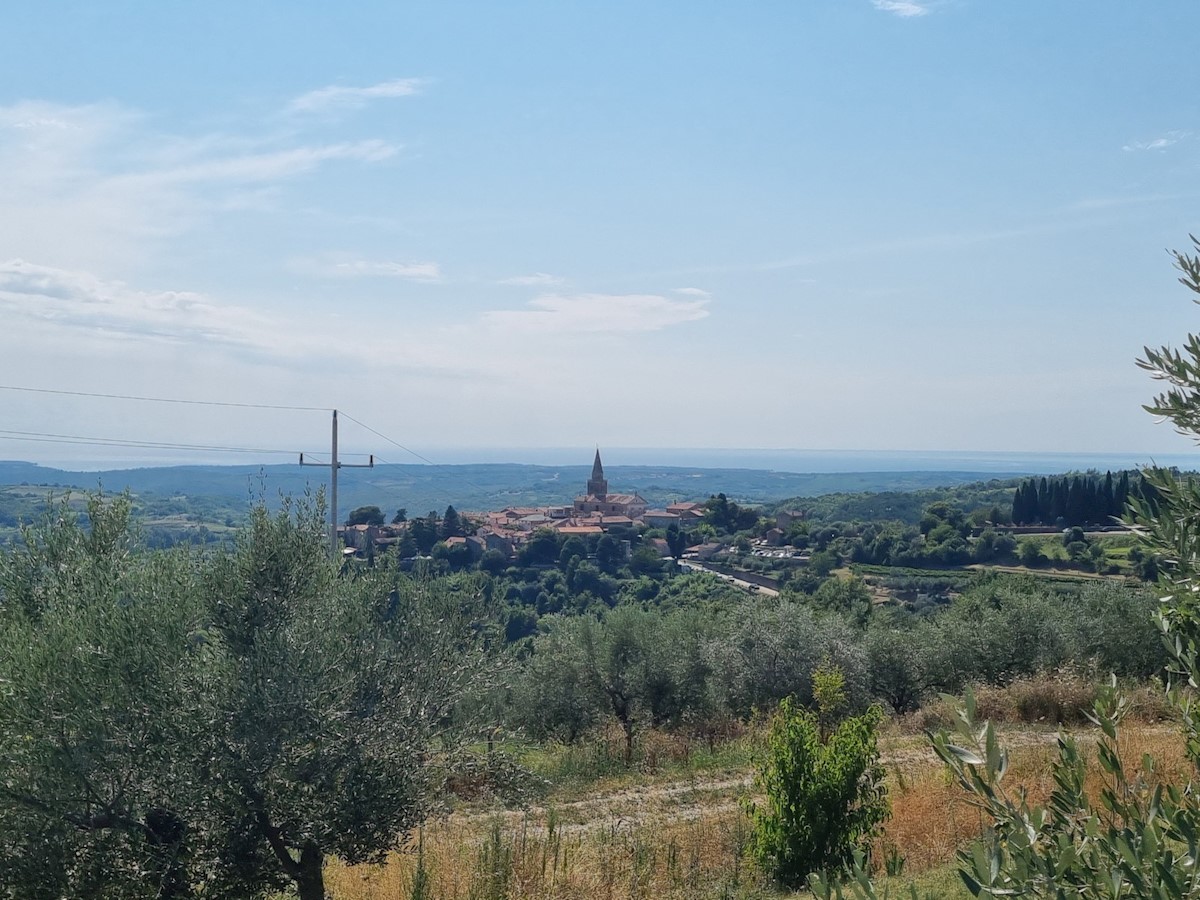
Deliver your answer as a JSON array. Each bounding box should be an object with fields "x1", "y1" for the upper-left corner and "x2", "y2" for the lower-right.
[{"x1": 509, "y1": 575, "x2": 1165, "y2": 761}]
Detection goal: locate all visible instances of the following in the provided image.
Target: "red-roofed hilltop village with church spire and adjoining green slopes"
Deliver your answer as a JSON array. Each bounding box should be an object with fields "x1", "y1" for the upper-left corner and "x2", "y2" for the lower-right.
[{"x1": 341, "y1": 449, "x2": 1142, "y2": 600}]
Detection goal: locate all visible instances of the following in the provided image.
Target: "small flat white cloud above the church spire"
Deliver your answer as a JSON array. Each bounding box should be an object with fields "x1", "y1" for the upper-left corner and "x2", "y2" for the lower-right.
[{"x1": 484, "y1": 294, "x2": 708, "y2": 334}]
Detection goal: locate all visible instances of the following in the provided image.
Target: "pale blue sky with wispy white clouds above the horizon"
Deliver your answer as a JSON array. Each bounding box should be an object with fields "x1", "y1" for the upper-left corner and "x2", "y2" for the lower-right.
[{"x1": 0, "y1": 0, "x2": 1200, "y2": 472}]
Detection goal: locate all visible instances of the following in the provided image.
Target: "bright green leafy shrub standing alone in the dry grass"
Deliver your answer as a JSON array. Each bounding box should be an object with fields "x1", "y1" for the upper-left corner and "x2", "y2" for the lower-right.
[{"x1": 750, "y1": 700, "x2": 888, "y2": 888}]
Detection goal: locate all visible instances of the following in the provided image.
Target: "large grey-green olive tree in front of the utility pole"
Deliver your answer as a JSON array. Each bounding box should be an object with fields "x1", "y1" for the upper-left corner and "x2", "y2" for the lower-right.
[{"x1": 204, "y1": 505, "x2": 496, "y2": 900}]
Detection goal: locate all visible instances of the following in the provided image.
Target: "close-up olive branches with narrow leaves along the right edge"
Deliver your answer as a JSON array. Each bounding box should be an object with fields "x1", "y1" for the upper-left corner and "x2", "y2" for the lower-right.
[{"x1": 814, "y1": 238, "x2": 1200, "y2": 900}]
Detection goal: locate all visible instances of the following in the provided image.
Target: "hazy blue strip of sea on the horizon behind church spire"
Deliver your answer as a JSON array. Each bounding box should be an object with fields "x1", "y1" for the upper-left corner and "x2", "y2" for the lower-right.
[{"x1": 396, "y1": 446, "x2": 1200, "y2": 475}]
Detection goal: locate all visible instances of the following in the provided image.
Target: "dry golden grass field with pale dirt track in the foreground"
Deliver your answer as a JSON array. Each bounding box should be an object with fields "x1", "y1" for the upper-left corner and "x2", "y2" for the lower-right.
[{"x1": 316, "y1": 722, "x2": 1189, "y2": 900}]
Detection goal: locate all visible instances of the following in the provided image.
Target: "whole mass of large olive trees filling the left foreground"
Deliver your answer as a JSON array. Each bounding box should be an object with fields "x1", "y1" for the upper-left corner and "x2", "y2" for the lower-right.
[{"x1": 0, "y1": 499, "x2": 496, "y2": 900}]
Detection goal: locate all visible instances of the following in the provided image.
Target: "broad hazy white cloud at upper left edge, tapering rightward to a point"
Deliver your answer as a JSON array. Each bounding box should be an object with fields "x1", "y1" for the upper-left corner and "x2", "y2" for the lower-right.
[{"x1": 0, "y1": 102, "x2": 398, "y2": 274}]
